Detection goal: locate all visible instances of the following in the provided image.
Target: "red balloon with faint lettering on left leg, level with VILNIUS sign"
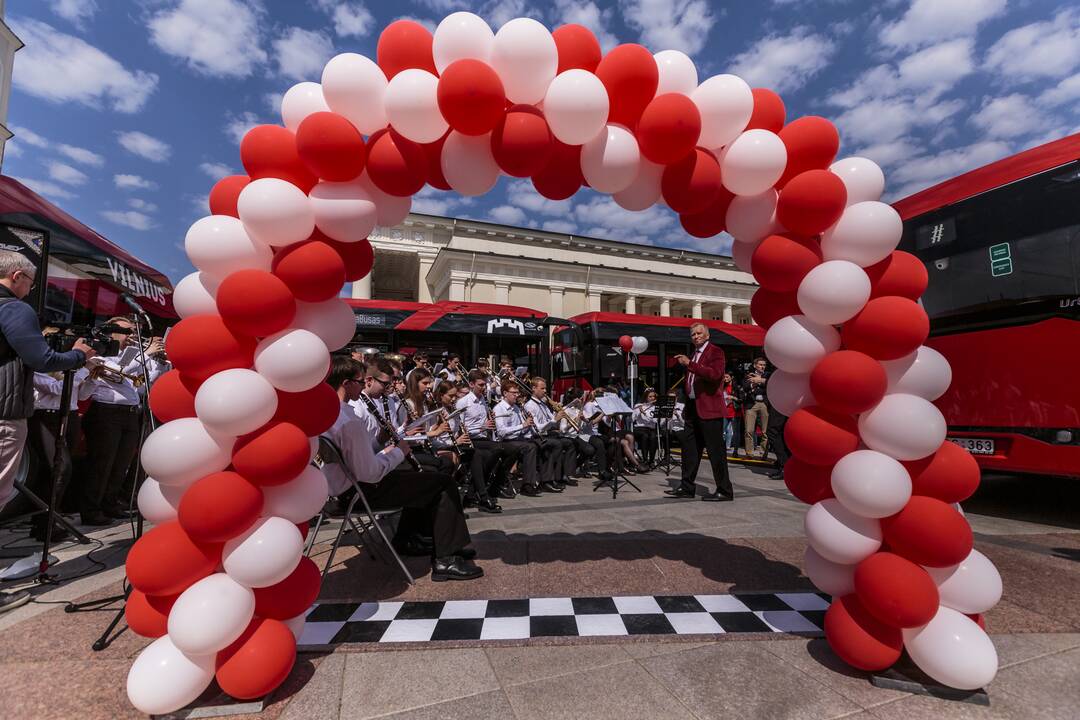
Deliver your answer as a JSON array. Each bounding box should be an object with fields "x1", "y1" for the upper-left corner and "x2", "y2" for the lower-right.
[{"x1": 217, "y1": 270, "x2": 296, "y2": 338}]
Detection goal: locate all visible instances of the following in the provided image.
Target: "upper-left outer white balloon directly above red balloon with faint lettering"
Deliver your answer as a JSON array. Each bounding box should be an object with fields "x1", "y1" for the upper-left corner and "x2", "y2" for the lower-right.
[{"x1": 184, "y1": 215, "x2": 273, "y2": 280}]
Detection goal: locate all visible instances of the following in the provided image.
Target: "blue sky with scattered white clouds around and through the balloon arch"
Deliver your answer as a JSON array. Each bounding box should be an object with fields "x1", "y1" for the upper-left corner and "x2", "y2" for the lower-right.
[{"x1": 3, "y1": 0, "x2": 1080, "y2": 281}]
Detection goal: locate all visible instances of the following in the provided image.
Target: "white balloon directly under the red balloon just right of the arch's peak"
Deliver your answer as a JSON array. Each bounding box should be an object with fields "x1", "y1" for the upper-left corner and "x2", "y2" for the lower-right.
[{"x1": 543, "y1": 69, "x2": 610, "y2": 145}]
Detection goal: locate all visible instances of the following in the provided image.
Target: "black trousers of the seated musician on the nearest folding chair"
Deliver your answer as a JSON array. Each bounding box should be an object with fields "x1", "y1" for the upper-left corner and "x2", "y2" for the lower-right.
[{"x1": 361, "y1": 470, "x2": 472, "y2": 557}]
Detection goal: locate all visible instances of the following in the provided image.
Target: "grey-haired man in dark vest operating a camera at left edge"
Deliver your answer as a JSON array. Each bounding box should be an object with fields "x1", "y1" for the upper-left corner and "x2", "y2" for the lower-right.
[{"x1": 0, "y1": 250, "x2": 95, "y2": 612}]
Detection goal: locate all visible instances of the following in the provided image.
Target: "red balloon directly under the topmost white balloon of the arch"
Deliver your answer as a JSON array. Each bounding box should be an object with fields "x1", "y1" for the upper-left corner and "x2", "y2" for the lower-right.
[{"x1": 436, "y1": 58, "x2": 507, "y2": 135}]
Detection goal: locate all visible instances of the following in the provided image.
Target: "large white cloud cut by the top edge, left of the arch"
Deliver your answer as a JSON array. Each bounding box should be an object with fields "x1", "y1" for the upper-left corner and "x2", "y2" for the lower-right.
[{"x1": 149, "y1": 0, "x2": 267, "y2": 78}]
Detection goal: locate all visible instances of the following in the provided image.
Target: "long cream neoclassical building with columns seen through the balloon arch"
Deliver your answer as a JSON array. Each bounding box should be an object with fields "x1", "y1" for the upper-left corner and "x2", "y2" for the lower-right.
[{"x1": 352, "y1": 213, "x2": 756, "y2": 323}]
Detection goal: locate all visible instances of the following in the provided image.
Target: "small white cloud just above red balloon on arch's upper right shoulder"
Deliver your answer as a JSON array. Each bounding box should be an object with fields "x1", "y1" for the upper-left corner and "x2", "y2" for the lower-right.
[{"x1": 731, "y1": 27, "x2": 836, "y2": 93}]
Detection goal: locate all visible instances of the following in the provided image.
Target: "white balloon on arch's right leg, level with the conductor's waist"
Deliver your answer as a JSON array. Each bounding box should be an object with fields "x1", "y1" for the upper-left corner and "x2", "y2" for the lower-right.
[{"x1": 859, "y1": 393, "x2": 946, "y2": 460}]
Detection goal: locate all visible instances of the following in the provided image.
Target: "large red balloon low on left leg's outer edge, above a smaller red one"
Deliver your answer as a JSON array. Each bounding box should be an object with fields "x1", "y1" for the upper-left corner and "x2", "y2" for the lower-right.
[{"x1": 125, "y1": 520, "x2": 221, "y2": 595}]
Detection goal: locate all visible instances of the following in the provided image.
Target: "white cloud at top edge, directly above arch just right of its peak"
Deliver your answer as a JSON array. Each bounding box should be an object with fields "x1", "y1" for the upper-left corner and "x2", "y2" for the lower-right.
[{"x1": 620, "y1": 0, "x2": 716, "y2": 55}]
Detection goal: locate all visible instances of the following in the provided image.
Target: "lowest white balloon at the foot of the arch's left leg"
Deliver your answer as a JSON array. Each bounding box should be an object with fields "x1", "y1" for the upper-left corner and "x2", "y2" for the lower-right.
[{"x1": 127, "y1": 635, "x2": 216, "y2": 715}]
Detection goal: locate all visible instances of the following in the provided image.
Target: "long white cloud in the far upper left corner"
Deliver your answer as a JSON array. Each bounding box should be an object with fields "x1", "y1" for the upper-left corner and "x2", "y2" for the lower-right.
[{"x1": 10, "y1": 17, "x2": 158, "y2": 112}]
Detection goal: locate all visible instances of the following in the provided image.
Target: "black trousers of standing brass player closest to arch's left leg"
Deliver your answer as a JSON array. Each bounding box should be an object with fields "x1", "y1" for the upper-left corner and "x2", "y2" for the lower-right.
[{"x1": 79, "y1": 402, "x2": 143, "y2": 515}]
